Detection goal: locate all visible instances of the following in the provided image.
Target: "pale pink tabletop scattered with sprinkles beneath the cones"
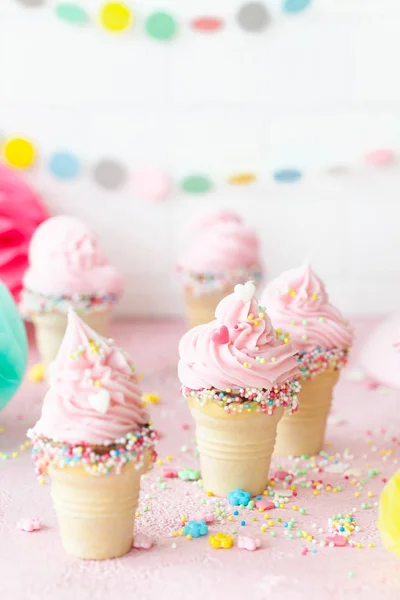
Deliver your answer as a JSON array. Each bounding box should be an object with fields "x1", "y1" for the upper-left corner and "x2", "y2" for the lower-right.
[{"x1": 0, "y1": 321, "x2": 400, "y2": 600}]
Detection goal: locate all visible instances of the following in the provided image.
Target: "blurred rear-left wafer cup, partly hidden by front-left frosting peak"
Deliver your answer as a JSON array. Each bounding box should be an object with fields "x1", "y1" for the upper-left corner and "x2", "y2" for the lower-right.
[{"x1": 32, "y1": 310, "x2": 111, "y2": 371}]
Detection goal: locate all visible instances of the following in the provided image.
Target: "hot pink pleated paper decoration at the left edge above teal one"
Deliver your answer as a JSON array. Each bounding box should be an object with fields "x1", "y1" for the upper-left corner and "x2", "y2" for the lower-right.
[{"x1": 0, "y1": 165, "x2": 49, "y2": 300}]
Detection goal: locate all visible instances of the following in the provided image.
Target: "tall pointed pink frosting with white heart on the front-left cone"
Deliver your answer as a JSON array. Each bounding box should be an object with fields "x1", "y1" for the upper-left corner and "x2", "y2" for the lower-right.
[{"x1": 34, "y1": 311, "x2": 149, "y2": 444}]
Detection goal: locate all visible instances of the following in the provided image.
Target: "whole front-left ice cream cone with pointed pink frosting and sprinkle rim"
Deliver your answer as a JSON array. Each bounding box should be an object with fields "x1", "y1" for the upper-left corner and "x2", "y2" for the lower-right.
[{"x1": 28, "y1": 311, "x2": 158, "y2": 560}]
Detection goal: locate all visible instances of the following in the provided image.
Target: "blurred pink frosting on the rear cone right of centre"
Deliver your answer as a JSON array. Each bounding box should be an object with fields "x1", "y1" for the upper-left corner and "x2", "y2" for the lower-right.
[{"x1": 178, "y1": 211, "x2": 260, "y2": 274}]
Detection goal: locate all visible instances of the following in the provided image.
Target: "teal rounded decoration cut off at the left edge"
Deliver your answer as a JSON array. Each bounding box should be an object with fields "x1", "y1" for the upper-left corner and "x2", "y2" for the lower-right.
[{"x1": 0, "y1": 281, "x2": 28, "y2": 410}]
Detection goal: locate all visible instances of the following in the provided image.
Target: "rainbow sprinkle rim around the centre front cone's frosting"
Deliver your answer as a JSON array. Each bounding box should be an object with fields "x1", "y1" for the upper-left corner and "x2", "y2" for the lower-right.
[{"x1": 181, "y1": 380, "x2": 300, "y2": 415}]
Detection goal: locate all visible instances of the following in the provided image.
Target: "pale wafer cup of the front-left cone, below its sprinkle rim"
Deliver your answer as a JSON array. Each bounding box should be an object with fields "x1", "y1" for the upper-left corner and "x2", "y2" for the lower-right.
[{"x1": 49, "y1": 464, "x2": 146, "y2": 560}]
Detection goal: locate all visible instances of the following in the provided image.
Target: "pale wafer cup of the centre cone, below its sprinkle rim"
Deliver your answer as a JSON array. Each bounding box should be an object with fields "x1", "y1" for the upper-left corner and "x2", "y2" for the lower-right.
[{"x1": 189, "y1": 399, "x2": 283, "y2": 496}]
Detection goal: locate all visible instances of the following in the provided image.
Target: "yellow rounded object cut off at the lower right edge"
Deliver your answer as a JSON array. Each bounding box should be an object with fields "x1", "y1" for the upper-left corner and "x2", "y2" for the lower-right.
[{"x1": 378, "y1": 471, "x2": 400, "y2": 557}]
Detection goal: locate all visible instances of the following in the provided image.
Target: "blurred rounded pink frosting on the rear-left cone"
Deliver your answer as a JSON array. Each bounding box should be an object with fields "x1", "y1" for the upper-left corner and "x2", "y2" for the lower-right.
[{"x1": 23, "y1": 215, "x2": 123, "y2": 296}]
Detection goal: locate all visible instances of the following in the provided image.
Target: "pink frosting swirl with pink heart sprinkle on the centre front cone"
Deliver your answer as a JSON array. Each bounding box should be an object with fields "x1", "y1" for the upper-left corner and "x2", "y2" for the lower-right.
[{"x1": 178, "y1": 282, "x2": 299, "y2": 390}]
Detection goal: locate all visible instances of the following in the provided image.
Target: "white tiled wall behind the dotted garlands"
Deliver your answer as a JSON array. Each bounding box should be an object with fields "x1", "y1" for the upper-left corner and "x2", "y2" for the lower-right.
[{"x1": 0, "y1": 0, "x2": 400, "y2": 315}]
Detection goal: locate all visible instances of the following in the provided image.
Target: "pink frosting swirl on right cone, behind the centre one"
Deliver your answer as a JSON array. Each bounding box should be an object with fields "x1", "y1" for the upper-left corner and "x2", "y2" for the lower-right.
[{"x1": 261, "y1": 264, "x2": 353, "y2": 352}]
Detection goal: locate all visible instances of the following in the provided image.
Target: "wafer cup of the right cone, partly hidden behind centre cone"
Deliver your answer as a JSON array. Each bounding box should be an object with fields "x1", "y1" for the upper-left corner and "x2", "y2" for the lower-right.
[{"x1": 275, "y1": 370, "x2": 340, "y2": 456}]
